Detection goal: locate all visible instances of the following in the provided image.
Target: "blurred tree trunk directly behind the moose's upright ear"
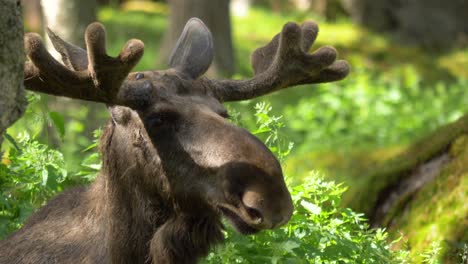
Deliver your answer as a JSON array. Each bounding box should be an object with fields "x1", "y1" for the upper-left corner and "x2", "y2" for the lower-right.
[{"x1": 159, "y1": 0, "x2": 234, "y2": 76}]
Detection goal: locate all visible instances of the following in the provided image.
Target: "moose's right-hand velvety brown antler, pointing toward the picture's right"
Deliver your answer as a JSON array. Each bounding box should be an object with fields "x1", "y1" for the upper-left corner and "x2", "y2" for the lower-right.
[{"x1": 211, "y1": 22, "x2": 349, "y2": 101}]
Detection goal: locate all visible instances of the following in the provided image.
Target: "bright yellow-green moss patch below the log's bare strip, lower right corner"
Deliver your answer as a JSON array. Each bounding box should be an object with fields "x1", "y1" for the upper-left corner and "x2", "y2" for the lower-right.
[{"x1": 390, "y1": 135, "x2": 468, "y2": 263}]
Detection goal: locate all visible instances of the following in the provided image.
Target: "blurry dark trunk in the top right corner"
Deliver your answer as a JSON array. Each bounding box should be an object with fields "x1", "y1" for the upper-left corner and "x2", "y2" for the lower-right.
[{"x1": 342, "y1": 0, "x2": 468, "y2": 50}]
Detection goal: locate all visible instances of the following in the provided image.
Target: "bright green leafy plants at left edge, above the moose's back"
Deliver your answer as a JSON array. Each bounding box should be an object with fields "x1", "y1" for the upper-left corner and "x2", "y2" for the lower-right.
[{"x1": 0, "y1": 133, "x2": 68, "y2": 238}]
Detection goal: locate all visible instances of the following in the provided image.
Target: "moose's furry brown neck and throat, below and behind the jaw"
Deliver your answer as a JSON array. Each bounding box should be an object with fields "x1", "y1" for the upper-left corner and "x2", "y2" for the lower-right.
[{"x1": 96, "y1": 116, "x2": 223, "y2": 263}]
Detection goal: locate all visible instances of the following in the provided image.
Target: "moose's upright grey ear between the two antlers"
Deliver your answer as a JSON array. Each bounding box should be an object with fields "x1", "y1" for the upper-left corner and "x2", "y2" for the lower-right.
[{"x1": 169, "y1": 18, "x2": 213, "y2": 79}]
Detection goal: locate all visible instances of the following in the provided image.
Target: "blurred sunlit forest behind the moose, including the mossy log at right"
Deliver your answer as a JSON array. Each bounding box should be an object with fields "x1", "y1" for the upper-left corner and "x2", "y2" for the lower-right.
[{"x1": 3, "y1": 0, "x2": 468, "y2": 263}]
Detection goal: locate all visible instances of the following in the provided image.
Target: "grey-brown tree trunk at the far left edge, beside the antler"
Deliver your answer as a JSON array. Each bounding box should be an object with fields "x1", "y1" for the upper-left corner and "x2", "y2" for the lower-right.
[{"x1": 0, "y1": 0, "x2": 27, "y2": 148}]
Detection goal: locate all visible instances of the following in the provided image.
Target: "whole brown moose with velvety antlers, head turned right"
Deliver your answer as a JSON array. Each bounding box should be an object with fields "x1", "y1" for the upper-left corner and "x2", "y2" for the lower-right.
[{"x1": 0, "y1": 18, "x2": 349, "y2": 264}]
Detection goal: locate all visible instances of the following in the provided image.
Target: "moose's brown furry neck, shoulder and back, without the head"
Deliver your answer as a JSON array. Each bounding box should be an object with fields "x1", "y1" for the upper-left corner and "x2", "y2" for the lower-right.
[{"x1": 0, "y1": 114, "x2": 223, "y2": 263}]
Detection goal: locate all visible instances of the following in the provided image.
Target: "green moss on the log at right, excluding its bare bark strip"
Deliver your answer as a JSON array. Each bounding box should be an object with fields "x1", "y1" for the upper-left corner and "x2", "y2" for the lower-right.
[{"x1": 328, "y1": 115, "x2": 468, "y2": 263}]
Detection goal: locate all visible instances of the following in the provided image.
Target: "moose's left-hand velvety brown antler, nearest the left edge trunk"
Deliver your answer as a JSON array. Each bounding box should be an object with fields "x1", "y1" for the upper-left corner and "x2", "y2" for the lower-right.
[{"x1": 24, "y1": 23, "x2": 144, "y2": 105}]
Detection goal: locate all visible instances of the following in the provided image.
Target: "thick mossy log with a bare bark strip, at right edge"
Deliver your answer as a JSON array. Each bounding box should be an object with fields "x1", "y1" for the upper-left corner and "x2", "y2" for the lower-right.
[{"x1": 358, "y1": 115, "x2": 468, "y2": 263}]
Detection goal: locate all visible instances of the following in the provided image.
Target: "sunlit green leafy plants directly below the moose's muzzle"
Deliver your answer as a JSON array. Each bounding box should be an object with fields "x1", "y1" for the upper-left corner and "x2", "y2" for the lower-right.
[{"x1": 205, "y1": 172, "x2": 404, "y2": 263}]
